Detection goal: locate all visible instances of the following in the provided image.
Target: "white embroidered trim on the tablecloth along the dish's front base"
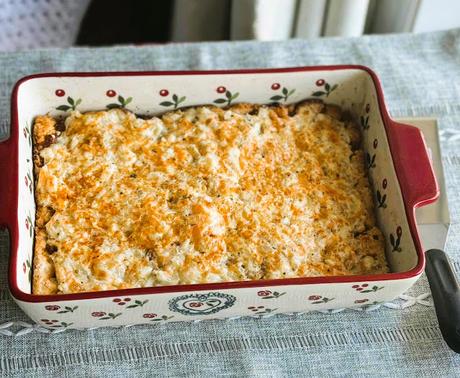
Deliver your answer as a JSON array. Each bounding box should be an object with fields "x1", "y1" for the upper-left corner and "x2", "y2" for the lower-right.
[{"x1": 0, "y1": 293, "x2": 433, "y2": 336}]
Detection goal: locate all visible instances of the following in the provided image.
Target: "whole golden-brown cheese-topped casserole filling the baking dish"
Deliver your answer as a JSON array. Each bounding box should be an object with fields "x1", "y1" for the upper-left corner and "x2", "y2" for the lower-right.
[{"x1": 33, "y1": 101, "x2": 388, "y2": 294}]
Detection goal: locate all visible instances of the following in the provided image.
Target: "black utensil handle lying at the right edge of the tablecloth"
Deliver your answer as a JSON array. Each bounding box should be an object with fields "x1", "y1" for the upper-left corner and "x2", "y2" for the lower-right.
[{"x1": 425, "y1": 249, "x2": 460, "y2": 353}]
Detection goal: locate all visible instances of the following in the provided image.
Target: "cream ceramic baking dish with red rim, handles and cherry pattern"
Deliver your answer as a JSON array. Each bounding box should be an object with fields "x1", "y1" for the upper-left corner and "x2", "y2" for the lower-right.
[{"x1": 0, "y1": 66, "x2": 438, "y2": 328}]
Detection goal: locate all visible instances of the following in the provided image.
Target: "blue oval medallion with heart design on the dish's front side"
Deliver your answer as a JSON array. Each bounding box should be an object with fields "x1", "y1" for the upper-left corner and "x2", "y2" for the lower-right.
[{"x1": 169, "y1": 293, "x2": 236, "y2": 315}]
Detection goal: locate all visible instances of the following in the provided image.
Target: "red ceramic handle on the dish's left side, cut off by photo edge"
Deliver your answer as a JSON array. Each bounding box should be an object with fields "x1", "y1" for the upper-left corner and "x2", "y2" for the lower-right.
[{"x1": 0, "y1": 138, "x2": 16, "y2": 228}]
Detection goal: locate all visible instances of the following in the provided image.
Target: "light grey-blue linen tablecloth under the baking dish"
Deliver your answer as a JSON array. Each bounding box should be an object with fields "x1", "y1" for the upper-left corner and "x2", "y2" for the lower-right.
[{"x1": 0, "y1": 30, "x2": 460, "y2": 377}]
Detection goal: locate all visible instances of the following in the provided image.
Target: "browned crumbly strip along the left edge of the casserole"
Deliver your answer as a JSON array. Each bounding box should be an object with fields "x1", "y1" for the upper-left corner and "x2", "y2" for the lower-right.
[{"x1": 32, "y1": 115, "x2": 59, "y2": 295}]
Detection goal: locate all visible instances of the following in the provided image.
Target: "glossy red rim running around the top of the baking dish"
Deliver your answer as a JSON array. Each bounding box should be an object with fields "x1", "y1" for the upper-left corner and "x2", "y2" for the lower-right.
[{"x1": 5, "y1": 65, "x2": 439, "y2": 303}]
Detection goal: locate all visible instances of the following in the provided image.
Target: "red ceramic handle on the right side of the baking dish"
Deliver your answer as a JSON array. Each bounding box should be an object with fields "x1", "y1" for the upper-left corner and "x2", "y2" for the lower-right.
[{"x1": 390, "y1": 122, "x2": 439, "y2": 209}]
